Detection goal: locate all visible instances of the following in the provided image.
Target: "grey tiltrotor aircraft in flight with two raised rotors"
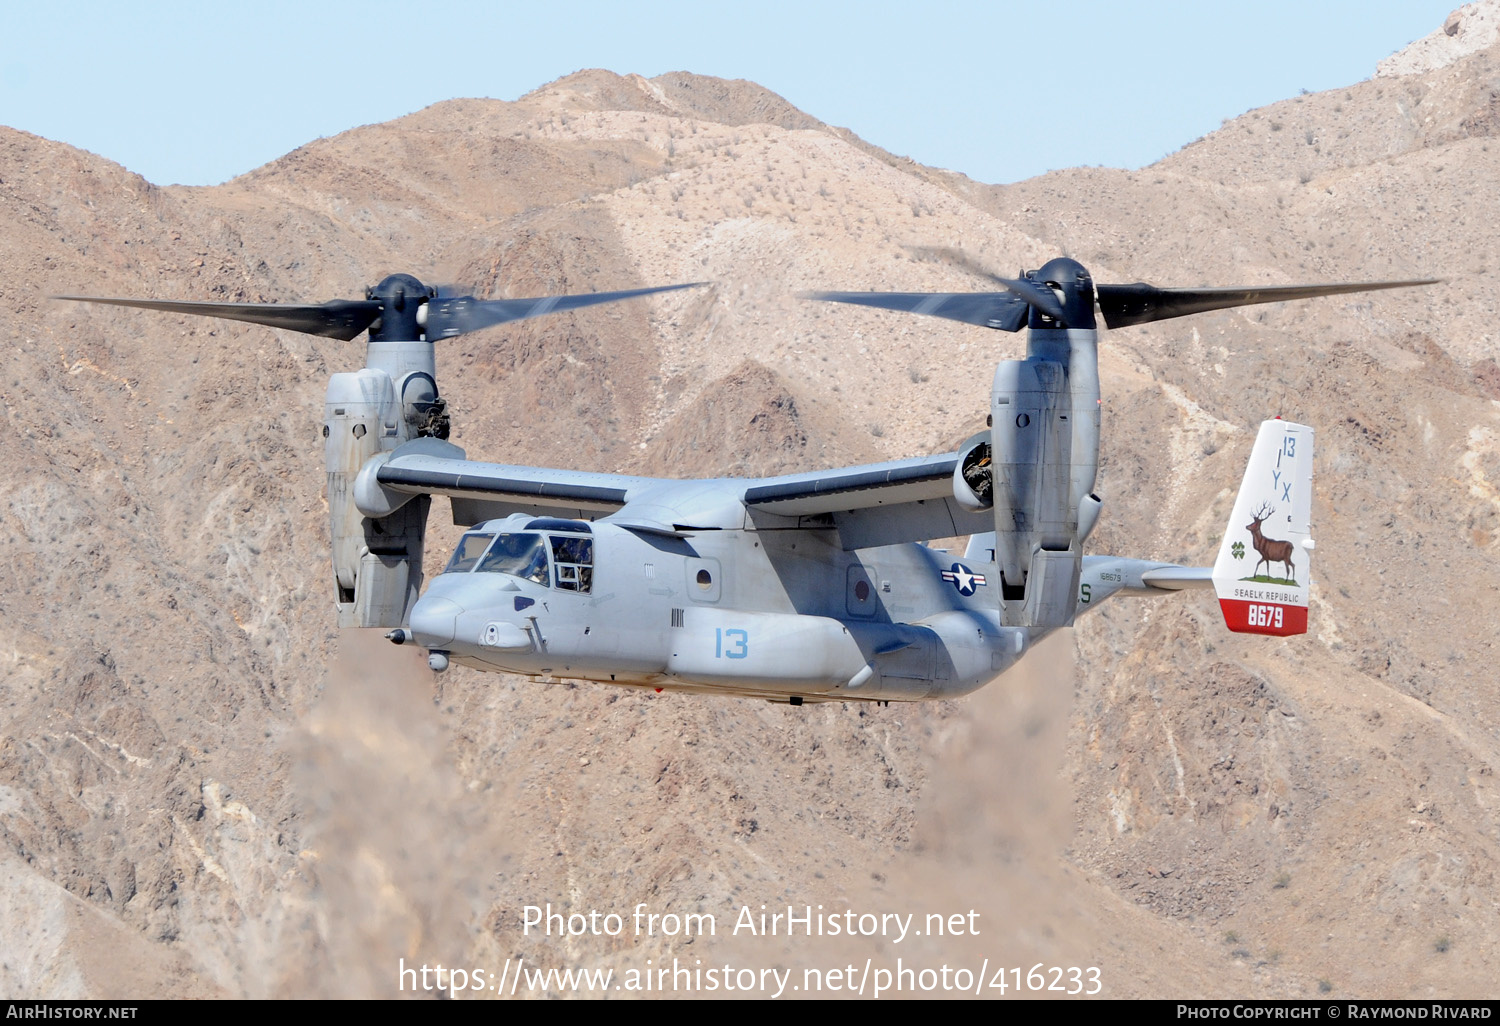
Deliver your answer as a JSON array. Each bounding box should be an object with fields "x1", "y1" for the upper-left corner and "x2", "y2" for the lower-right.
[{"x1": 66, "y1": 258, "x2": 1427, "y2": 705}]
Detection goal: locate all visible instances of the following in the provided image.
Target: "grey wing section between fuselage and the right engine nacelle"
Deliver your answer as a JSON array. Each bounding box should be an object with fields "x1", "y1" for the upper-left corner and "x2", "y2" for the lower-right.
[{"x1": 744, "y1": 453, "x2": 995, "y2": 549}]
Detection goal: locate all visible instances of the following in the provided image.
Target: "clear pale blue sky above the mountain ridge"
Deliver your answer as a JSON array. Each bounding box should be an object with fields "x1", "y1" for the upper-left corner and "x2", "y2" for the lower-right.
[{"x1": 0, "y1": 0, "x2": 1458, "y2": 185}]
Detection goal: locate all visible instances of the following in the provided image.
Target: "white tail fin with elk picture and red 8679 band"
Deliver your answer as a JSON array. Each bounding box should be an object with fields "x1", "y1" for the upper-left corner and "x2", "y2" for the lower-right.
[{"x1": 1214, "y1": 420, "x2": 1313, "y2": 636}]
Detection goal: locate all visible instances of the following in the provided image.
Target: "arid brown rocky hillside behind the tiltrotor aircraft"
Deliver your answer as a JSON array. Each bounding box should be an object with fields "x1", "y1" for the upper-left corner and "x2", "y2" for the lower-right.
[{"x1": 0, "y1": 0, "x2": 1500, "y2": 998}]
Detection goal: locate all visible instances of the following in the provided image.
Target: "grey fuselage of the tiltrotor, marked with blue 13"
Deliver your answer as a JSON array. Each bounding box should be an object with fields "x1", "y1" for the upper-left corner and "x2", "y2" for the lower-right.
[{"x1": 411, "y1": 515, "x2": 1038, "y2": 701}]
